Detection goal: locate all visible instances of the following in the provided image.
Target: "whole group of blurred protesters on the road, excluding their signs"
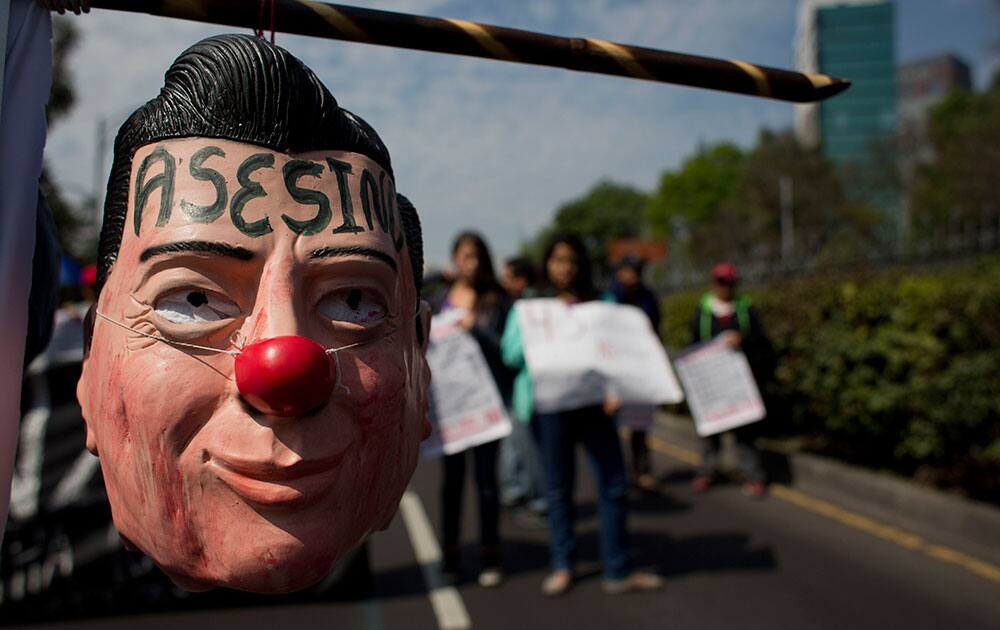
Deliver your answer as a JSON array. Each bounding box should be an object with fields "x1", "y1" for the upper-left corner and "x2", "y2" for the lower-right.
[{"x1": 426, "y1": 232, "x2": 773, "y2": 597}]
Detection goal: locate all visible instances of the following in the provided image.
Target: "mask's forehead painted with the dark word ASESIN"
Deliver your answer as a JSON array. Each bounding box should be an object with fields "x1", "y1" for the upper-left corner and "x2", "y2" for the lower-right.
[{"x1": 131, "y1": 138, "x2": 404, "y2": 251}]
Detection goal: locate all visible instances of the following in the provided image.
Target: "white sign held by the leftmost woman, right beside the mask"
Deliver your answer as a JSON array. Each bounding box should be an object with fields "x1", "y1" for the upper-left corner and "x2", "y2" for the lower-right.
[{"x1": 420, "y1": 309, "x2": 511, "y2": 458}]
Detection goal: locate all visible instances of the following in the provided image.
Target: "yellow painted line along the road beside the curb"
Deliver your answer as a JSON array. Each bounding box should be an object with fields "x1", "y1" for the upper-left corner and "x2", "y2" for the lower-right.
[{"x1": 649, "y1": 435, "x2": 1000, "y2": 582}]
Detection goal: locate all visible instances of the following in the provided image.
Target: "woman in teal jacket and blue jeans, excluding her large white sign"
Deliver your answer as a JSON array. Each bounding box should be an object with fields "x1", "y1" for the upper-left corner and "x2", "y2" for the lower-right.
[{"x1": 502, "y1": 234, "x2": 662, "y2": 596}]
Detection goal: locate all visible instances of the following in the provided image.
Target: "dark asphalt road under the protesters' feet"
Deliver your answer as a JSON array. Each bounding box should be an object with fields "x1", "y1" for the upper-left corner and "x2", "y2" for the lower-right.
[{"x1": 31, "y1": 428, "x2": 1000, "y2": 630}]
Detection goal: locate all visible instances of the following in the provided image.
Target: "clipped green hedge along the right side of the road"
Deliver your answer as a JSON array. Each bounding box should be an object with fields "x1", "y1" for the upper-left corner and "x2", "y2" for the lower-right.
[{"x1": 661, "y1": 258, "x2": 1000, "y2": 502}]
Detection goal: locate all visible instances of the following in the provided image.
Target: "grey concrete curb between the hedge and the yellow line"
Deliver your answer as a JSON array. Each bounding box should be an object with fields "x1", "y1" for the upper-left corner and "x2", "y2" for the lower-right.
[{"x1": 653, "y1": 414, "x2": 1000, "y2": 563}]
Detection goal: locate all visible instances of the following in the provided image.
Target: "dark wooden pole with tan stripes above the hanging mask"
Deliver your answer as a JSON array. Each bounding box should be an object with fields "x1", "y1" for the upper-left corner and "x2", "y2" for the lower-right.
[{"x1": 90, "y1": 0, "x2": 850, "y2": 103}]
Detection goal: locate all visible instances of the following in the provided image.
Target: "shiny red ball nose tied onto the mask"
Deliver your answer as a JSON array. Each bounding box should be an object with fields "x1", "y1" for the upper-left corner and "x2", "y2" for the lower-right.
[{"x1": 236, "y1": 336, "x2": 333, "y2": 416}]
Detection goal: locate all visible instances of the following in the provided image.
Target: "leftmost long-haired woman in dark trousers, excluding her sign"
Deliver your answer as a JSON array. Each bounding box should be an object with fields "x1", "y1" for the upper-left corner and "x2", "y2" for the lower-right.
[{"x1": 430, "y1": 232, "x2": 510, "y2": 588}]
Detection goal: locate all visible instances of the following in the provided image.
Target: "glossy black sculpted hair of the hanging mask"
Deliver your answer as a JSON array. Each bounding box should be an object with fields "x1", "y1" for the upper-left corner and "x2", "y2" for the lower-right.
[{"x1": 96, "y1": 35, "x2": 414, "y2": 292}]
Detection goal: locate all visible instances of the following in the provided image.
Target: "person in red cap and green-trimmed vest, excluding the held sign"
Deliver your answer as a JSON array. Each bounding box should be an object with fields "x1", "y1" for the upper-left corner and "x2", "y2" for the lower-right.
[{"x1": 691, "y1": 262, "x2": 774, "y2": 497}]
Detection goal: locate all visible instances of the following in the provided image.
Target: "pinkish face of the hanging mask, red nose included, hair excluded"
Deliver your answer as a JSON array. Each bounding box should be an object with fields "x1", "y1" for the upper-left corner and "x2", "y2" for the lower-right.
[{"x1": 78, "y1": 138, "x2": 430, "y2": 593}]
